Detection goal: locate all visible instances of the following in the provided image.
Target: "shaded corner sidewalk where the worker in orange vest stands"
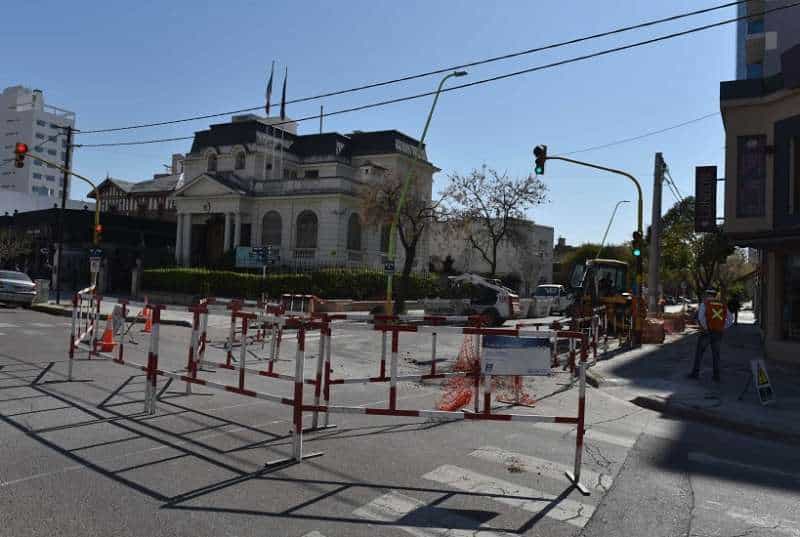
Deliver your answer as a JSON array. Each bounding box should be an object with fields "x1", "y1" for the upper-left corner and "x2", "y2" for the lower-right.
[{"x1": 588, "y1": 311, "x2": 800, "y2": 443}]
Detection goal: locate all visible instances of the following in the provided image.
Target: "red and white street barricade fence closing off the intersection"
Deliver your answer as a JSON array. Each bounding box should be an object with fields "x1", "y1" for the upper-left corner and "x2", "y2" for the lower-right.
[{"x1": 69, "y1": 288, "x2": 590, "y2": 494}]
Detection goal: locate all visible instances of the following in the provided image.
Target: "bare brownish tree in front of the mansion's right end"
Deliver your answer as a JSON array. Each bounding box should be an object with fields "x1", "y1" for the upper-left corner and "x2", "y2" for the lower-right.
[{"x1": 360, "y1": 173, "x2": 442, "y2": 313}]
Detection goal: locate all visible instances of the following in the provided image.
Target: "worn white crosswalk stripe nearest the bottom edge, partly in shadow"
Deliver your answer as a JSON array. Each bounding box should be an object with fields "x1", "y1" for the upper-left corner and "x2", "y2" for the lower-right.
[{"x1": 353, "y1": 491, "x2": 516, "y2": 537}]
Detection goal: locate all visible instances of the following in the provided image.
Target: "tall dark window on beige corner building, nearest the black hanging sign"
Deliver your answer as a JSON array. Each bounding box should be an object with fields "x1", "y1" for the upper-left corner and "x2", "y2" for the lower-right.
[{"x1": 736, "y1": 134, "x2": 767, "y2": 218}]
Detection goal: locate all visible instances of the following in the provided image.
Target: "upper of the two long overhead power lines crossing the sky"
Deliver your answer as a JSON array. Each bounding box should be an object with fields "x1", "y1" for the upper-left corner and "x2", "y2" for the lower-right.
[{"x1": 76, "y1": 0, "x2": 748, "y2": 134}]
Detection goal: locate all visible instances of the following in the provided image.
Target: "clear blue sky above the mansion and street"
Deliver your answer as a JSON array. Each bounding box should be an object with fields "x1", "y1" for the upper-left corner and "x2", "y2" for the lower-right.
[{"x1": 0, "y1": 0, "x2": 736, "y2": 243}]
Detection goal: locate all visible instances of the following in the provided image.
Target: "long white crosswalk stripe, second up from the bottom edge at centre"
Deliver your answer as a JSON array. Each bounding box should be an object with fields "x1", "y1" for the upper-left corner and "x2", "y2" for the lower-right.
[{"x1": 422, "y1": 464, "x2": 594, "y2": 528}]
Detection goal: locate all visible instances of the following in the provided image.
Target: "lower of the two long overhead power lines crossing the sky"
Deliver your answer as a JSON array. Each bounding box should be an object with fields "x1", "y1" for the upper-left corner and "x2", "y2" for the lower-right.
[{"x1": 72, "y1": 1, "x2": 800, "y2": 147}]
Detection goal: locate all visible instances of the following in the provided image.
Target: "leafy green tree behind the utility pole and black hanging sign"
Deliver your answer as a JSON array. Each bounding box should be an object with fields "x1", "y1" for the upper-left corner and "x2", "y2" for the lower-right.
[{"x1": 661, "y1": 196, "x2": 735, "y2": 296}]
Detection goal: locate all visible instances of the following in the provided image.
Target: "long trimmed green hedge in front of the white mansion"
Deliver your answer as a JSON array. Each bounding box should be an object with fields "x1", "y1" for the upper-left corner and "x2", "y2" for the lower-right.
[{"x1": 143, "y1": 268, "x2": 439, "y2": 300}]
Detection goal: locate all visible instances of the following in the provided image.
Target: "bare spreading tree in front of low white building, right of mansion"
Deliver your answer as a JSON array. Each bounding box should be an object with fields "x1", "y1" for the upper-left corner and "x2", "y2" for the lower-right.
[{"x1": 444, "y1": 169, "x2": 547, "y2": 276}]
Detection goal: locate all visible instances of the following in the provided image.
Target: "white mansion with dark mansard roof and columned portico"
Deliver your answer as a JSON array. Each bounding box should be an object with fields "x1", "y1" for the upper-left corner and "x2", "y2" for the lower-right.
[{"x1": 172, "y1": 115, "x2": 439, "y2": 267}]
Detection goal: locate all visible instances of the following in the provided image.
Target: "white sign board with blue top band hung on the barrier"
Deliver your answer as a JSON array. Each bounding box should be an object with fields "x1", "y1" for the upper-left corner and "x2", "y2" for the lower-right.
[{"x1": 483, "y1": 335, "x2": 552, "y2": 376}]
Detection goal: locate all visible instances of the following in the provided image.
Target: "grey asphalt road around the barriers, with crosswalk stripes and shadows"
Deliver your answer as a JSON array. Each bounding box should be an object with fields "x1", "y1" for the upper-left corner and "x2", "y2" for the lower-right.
[{"x1": 0, "y1": 310, "x2": 800, "y2": 537}]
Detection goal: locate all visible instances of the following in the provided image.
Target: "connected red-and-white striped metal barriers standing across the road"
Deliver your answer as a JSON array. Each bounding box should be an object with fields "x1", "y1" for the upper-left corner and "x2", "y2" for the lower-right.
[{"x1": 69, "y1": 298, "x2": 589, "y2": 494}]
